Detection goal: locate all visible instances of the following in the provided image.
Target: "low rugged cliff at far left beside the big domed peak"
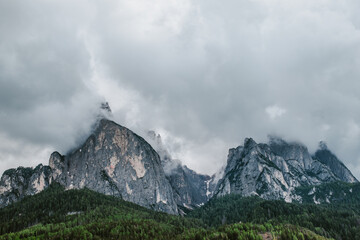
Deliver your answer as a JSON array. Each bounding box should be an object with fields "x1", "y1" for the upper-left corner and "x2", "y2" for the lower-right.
[{"x1": 0, "y1": 164, "x2": 52, "y2": 207}]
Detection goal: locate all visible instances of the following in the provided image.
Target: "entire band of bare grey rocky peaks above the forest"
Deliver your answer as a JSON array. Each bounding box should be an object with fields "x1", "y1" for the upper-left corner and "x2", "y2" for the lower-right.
[{"x1": 0, "y1": 115, "x2": 357, "y2": 214}]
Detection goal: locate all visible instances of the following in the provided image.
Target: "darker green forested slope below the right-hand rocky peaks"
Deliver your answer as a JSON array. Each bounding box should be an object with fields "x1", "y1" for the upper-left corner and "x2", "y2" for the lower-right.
[{"x1": 188, "y1": 187, "x2": 360, "y2": 240}]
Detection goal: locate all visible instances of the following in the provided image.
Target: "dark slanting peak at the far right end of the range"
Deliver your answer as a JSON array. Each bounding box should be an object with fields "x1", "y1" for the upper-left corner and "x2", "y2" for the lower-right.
[{"x1": 314, "y1": 142, "x2": 358, "y2": 183}]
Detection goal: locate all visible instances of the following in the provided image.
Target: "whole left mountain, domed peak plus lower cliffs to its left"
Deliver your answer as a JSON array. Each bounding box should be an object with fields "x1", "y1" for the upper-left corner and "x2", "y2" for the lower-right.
[{"x1": 0, "y1": 119, "x2": 178, "y2": 214}]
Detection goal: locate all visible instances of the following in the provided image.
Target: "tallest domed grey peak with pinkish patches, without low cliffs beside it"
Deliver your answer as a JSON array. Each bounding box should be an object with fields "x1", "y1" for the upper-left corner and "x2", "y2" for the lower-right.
[{"x1": 60, "y1": 119, "x2": 177, "y2": 213}]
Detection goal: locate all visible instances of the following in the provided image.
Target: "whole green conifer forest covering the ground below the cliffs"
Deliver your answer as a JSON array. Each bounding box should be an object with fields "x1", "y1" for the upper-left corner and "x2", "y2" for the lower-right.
[{"x1": 0, "y1": 183, "x2": 360, "y2": 240}]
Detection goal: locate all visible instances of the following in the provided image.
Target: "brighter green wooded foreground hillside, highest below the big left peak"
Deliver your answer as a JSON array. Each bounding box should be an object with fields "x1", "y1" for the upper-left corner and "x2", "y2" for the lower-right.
[{"x1": 0, "y1": 184, "x2": 326, "y2": 239}]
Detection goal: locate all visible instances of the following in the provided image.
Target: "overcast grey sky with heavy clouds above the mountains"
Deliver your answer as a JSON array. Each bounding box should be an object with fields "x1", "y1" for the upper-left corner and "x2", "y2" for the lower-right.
[{"x1": 0, "y1": 0, "x2": 360, "y2": 179}]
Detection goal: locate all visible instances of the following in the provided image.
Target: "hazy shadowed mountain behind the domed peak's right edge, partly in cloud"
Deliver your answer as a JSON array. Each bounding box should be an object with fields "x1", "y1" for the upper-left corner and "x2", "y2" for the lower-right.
[{"x1": 147, "y1": 131, "x2": 211, "y2": 211}]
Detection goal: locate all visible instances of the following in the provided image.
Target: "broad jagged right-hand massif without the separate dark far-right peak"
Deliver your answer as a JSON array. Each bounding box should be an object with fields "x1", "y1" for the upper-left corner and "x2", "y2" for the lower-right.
[{"x1": 215, "y1": 138, "x2": 352, "y2": 202}]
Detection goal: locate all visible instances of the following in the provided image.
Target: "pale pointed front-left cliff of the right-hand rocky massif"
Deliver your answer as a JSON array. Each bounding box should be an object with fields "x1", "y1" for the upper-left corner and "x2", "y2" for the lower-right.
[{"x1": 215, "y1": 139, "x2": 299, "y2": 201}]
